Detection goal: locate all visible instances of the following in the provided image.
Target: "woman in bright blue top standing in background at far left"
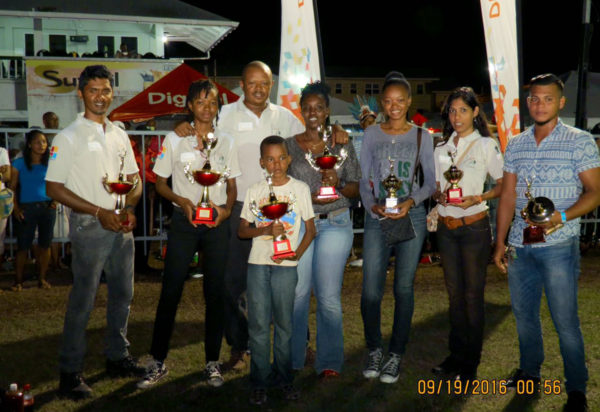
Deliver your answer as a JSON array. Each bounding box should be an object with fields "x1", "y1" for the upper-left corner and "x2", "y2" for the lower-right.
[{"x1": 10, "y1": 129, "x2": 56, "y2": 291}]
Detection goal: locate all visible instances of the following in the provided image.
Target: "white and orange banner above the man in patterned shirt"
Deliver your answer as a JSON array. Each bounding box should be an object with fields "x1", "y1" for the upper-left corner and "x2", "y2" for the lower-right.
[{"x1": 481, "y1": 0, "x2": 521, "y2": 152}]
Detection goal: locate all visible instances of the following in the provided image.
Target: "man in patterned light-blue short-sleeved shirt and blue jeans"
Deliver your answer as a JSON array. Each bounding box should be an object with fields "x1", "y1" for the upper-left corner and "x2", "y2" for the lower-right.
[{"x1": 494, "y1": 74, "x2": 600, "y2": 411}]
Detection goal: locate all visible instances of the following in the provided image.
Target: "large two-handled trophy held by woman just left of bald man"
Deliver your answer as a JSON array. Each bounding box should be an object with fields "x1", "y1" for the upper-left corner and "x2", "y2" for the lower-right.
[{"x1": 183, "y1": 133, "x2": 230, "y2": 224}]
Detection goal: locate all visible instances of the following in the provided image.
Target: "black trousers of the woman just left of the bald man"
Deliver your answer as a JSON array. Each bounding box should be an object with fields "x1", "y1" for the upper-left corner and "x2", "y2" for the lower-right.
[{"x1": 150, "y1": 208, "x2": 228, "y2": 362}]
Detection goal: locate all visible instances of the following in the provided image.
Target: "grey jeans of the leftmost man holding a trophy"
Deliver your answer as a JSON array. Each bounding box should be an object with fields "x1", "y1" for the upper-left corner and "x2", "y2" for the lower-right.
[{"x1": 59, "y1": 213, "x2": 134, "y2": 373}]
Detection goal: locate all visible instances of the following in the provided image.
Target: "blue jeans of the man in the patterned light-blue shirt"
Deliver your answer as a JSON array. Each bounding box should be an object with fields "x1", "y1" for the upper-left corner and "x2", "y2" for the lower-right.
[{"x1": 508, "y1": 237, "x2": 588, "y2": 392}]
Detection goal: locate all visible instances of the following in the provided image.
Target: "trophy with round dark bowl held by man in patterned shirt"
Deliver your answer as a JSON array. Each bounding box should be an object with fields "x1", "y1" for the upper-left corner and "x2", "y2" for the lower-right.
[{"x1": 521, "y1": 177, "x2": 564, "y2": 245}]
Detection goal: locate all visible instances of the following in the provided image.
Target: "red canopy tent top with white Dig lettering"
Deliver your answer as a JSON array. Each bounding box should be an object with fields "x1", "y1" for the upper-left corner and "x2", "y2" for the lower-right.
[{"x1": 109, "y1": 64, "x2": 239, "y2": 121}]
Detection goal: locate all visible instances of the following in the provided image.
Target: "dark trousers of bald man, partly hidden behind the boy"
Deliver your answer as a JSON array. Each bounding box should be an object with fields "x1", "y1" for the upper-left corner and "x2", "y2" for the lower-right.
[{"x1": 225, "y1": 202, "x2": 252, "y2": 351}]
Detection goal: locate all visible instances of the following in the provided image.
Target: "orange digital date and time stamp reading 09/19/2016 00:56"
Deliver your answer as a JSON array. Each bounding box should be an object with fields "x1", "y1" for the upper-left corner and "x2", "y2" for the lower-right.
[{"x1": 417, "y1": 379, "x2": 562, "y2": 395}]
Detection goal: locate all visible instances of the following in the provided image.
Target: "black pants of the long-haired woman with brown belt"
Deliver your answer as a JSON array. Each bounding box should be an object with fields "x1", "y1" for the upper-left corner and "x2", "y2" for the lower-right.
[{"x1": 437, "y1": 217, "x2": 492, "y2": 374}]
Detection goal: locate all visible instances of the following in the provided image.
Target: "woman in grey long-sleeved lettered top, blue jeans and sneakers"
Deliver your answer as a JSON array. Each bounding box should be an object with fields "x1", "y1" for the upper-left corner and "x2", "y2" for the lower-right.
[{"x1": 360, "y1": 72, "x2": 435, "y2": 383}]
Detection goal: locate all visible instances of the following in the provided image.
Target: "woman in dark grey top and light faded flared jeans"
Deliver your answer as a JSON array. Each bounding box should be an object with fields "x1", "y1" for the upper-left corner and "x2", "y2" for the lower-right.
[{"x1": 286, "y1": 82, "x2": 360, "y2": 378}]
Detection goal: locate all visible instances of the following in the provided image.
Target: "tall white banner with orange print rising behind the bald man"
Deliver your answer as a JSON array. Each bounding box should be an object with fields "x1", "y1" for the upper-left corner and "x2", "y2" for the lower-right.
[{"x1": 277, "y1": 0, "x2": 321, "y2": 121}]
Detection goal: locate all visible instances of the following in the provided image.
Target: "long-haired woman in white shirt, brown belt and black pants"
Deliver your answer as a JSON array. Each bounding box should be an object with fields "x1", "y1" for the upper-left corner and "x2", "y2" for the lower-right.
[{"x1": 432, "y1": 87, "x2": 503, "y2": 382}]
